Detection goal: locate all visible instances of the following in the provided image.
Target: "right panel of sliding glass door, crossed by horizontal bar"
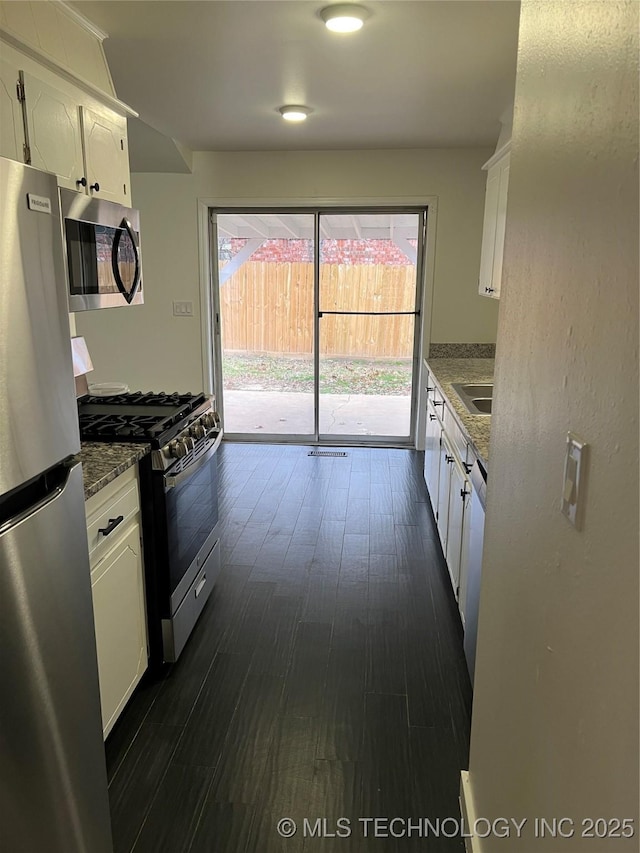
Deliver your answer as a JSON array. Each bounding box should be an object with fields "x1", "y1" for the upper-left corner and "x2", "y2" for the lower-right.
[{"x1": 318, "y1": 213, "x2": 421, "y2": 442}]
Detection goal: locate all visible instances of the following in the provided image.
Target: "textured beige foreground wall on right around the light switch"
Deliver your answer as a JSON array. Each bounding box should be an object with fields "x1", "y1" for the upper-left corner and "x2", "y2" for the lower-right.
[{"x1": 470, "y1": 0, "x2": 640, "y2": 853}]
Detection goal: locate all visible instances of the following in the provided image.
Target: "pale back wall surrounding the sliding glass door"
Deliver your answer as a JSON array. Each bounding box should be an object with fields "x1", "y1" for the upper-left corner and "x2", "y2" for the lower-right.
[{"x1": 77, "y1": 149, "x2": 497, "y2": 391}]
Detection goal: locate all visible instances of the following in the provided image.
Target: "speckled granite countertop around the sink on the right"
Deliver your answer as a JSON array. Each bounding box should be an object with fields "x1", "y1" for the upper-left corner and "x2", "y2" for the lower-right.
[{"x1": 426, "y1": 358, "x2": 495, "y2": 468}]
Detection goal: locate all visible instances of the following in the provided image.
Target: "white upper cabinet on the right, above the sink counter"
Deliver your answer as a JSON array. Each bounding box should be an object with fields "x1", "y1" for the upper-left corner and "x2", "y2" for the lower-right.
[{"x1": 478, "y1": 145, "x2": 510, "y2": 299}]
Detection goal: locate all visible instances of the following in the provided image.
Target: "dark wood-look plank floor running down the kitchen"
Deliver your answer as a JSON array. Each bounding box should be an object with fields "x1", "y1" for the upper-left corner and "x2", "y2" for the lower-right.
[{"x1": 107, "y1": 444, "x2": 471, "y2": 853}]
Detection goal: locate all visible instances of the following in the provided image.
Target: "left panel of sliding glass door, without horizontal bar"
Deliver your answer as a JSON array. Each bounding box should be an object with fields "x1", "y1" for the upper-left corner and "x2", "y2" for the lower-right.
[{"x1": 216, "y1": 212, "x2": 316, "y2": 439}]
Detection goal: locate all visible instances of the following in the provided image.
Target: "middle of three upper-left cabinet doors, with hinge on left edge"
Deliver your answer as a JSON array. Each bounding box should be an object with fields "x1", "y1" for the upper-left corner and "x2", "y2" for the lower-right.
[{"x1": 23, "y1": 73, "x2": 85, "y2": 190}]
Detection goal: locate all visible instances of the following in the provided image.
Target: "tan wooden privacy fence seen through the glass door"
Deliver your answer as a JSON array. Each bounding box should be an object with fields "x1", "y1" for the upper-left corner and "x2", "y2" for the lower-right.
[{"x1": 220, "y1": 262, "x2": 416, "y2": 358}]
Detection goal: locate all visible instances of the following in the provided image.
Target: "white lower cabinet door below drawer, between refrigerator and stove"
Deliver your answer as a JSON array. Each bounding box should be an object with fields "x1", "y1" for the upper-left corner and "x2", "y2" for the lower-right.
[{"x1": 91, "y1": 522, "x2": 147, "y2": 737}]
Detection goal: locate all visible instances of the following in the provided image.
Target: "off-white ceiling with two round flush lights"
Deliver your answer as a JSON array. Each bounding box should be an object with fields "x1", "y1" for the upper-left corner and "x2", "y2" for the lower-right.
[{"x1": 72, "y1": 0, "x2": 519, "y2": 156}]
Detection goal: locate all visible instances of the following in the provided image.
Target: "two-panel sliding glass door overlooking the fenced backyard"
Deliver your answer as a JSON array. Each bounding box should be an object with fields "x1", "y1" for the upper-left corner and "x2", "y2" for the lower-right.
[{"x1": 212, "y1": 209, "x2": 426, "y2": 444}]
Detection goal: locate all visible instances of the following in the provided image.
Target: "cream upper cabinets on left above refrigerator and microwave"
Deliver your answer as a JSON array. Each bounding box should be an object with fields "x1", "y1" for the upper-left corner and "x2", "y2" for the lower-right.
[{"x1": 0, "y1": 0, "x2": 137, "y2": 206}]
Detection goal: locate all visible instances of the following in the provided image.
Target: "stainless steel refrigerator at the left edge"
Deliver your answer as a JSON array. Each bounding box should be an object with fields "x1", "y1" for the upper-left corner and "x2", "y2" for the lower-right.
[{"x1": 0, "y1": 158, "x2": 113, "y2": 853}]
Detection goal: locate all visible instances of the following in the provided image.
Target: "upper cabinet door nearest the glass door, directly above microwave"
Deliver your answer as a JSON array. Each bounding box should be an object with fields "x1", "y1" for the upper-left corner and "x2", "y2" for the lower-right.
[{"x1": 81, "y1": 107, "x2": 131, "y2": 206}]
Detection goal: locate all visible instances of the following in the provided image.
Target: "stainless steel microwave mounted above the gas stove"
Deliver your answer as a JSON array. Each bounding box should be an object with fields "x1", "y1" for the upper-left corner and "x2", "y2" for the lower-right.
[{"x1": 60, "y1": 189, "x2": 144, "y2": 311}]
